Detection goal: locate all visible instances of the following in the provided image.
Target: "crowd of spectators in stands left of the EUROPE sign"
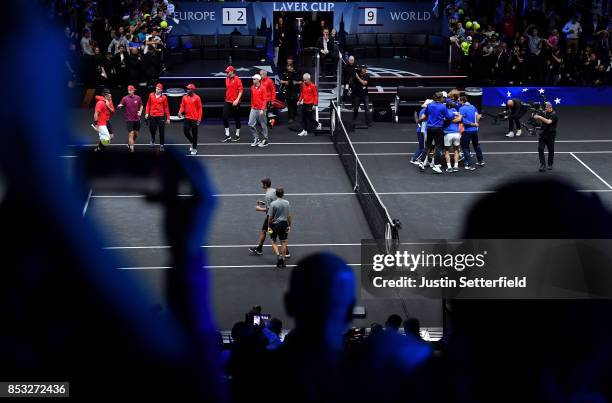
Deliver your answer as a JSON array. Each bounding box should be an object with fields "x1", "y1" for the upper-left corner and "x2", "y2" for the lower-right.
[{"x1": 48, "y1": 0, "x2": 171, "y2": 88}]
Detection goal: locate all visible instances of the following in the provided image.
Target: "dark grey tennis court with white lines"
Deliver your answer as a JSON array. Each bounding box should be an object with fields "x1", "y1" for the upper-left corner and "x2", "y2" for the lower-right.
[{"x1": 65, "y1": 103, "x2": 612, "y2": 329}]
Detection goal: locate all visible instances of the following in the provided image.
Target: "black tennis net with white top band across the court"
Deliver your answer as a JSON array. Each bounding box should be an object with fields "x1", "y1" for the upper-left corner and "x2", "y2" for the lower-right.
[{"x1": 330, "y1": 100, "x2": 400, "y2": 249}]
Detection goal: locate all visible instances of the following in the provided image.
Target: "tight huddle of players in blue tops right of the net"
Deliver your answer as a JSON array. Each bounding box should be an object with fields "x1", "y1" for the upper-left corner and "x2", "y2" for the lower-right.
[{"x1": 410, "y1": 90, "x2": 485, "y2": 174}]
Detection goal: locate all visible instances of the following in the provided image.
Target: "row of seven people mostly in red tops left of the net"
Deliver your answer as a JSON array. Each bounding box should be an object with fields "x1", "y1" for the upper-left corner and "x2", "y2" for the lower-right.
[{"x1": 92, "y1": 66, "x2": 320, "y2": 155}]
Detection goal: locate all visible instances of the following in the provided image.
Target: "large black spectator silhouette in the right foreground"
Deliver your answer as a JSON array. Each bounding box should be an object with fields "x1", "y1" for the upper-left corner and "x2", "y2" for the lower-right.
[{"x1": 447, "y1": 179, "x2": 612, "y2": 402}]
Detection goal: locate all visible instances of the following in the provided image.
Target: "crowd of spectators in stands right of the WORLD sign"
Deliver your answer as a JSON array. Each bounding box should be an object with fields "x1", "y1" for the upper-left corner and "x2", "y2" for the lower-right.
[{"x1": 445, "y1": 0, "x2": 612, "y2": 85}]
